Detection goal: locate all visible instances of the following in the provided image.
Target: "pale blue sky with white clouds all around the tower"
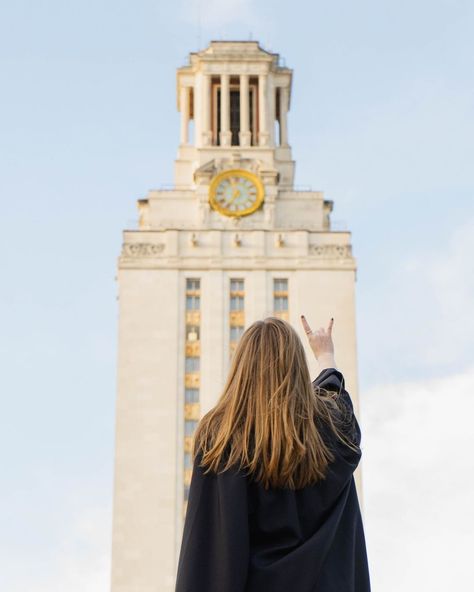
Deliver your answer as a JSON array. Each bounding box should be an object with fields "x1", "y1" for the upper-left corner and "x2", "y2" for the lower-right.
[{"x1": 0, "y1": 0, "x2": 474, "y2": 592}]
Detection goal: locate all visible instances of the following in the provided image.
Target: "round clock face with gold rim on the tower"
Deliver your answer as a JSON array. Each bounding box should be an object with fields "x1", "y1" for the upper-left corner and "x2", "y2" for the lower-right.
[{"x1": 209, "y1": 170, "x2": 263, "y2": 216}]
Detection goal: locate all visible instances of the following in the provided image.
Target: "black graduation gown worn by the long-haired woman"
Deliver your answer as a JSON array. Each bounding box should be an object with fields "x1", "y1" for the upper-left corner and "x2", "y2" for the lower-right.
[{"x1": 175, "y1": 368, "x2": 370, "y2": 592}]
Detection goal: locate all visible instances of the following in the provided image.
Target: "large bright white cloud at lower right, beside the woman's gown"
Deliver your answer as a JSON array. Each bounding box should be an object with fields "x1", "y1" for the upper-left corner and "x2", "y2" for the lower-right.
[{"x1": 360, "y1": 367, "x2": 474, "y2": 592}]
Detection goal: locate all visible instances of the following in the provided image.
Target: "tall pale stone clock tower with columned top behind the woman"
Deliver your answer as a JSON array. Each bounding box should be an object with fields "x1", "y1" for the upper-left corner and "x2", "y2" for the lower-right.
[{"x1": 112, "y1": 41, "x2": 361, "y2": 592}]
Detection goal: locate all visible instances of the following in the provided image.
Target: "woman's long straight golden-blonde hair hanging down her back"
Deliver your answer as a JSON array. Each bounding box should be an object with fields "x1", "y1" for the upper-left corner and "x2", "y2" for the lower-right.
[{"x1": 193, "y1": 317, "x2": 358, "y2": 489}]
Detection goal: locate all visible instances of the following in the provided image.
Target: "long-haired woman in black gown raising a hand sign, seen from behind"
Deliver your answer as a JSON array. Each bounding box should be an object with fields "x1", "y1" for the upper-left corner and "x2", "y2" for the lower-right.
[{"x1": 176, "y1": 315, "x2": 370, "y2": 592}]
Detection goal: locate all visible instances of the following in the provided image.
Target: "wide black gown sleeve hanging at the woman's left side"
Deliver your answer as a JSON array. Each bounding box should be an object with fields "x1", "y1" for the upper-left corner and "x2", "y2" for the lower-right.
[{"x1": 175, "y1": 452, "x2": 249, "y2": 592}]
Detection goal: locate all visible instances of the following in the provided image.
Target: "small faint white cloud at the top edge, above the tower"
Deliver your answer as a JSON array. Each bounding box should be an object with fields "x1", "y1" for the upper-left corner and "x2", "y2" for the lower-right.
[{"x1": 181, "y1": 0, "x2": 255, "y2": 29}]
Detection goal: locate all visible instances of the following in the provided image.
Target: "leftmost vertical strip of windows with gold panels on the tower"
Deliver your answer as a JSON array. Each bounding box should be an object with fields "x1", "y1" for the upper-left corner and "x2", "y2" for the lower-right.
[{"x1": 183, "y1": 278, "x2": 201, "y2": 519}]
